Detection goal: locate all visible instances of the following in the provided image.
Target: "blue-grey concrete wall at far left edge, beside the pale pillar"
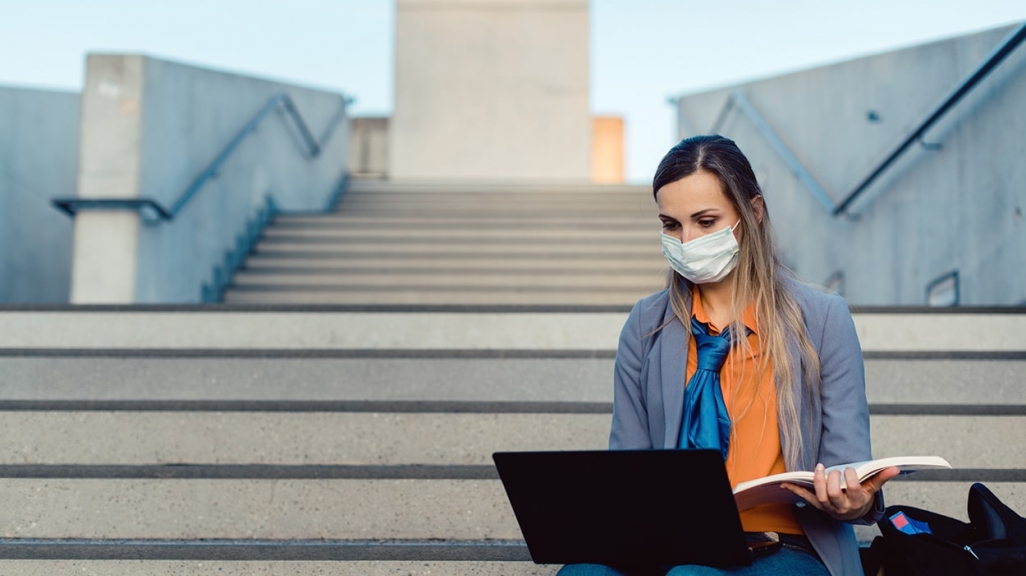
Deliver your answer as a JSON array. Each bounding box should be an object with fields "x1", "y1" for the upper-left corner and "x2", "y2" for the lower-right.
[{"x1": 0, "y1": 86, "x2": 80, "y2": 304}]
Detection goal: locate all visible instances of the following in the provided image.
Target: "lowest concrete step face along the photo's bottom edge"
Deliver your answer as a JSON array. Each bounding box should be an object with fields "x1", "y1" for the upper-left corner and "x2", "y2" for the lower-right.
[{"x1": 0, "y1": 558, "x2": 559, "y2": 576}]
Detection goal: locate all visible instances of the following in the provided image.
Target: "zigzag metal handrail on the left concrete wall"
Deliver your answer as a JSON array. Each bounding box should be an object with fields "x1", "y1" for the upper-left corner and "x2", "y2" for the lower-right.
[{"x1": 51, "y1": 92, "x2": 349, "y2": 223}]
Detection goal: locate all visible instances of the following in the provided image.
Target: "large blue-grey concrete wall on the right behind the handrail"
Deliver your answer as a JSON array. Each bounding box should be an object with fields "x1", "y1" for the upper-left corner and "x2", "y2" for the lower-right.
[{"x1": 678, "y1": 27, "x2": 1026, "y2": 305}]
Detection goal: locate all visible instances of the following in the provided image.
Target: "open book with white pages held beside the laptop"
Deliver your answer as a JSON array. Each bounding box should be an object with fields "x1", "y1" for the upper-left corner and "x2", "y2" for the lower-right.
[{"x1": 734, "y1": 456, "x2": 951, "y2": 510}]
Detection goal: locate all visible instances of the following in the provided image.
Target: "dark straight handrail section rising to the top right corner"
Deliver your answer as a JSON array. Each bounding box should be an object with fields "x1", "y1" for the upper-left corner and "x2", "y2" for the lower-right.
[{"x1": 833, "y1": 23, "x2": 1026, "y2": 216}]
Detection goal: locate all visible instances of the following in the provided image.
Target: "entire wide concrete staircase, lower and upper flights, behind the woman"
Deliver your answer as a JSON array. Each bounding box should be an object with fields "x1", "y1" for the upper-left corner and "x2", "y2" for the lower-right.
[{"x1": 0, "y1": 178, "x2": 1026, "y2": 576}]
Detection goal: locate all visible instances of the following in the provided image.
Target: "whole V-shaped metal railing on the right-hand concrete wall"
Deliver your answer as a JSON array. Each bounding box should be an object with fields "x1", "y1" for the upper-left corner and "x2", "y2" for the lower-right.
[{"x1": 693, "y1": 24, "x2": 1026, "y2": 217}]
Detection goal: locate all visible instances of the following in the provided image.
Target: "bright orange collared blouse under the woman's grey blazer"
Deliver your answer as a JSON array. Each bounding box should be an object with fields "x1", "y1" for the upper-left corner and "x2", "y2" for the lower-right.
[{"x1": 684, "y1": 290, "x2": 802, "y2": 534}]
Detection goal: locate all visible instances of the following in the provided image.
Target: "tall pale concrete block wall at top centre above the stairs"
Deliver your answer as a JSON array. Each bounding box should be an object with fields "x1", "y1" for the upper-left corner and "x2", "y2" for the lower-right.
[{"x1": 389, "y1": 0, "x2": 591, "y2": 181}]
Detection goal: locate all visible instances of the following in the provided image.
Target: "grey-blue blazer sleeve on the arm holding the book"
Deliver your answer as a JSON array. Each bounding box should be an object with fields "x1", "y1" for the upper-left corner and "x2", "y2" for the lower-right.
[{"x1": 819, "y1": 297, "x2": 883, "y2": 524}]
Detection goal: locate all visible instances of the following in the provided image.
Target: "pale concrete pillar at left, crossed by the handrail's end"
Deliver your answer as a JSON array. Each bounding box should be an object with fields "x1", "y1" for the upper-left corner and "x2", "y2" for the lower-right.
[{"x1": 71, "y1": 54, "x2": 145, "y2": 304}]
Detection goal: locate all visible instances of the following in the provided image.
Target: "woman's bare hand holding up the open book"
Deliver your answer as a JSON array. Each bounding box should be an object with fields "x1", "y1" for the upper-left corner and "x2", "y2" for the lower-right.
[{"x1": 781, "y1": 464, "x2": 899, "y2": 522}]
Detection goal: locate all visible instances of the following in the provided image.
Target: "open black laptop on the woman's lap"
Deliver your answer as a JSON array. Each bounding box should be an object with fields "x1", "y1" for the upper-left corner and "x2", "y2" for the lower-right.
[{"x1": 491, "y1": 450, "x2": 751, "y2": 573}]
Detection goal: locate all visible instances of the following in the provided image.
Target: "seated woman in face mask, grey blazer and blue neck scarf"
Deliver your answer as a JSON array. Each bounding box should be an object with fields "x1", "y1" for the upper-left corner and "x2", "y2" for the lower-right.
[{"x1": 559, "y1": 136, "x2": 898, "y2": 576}]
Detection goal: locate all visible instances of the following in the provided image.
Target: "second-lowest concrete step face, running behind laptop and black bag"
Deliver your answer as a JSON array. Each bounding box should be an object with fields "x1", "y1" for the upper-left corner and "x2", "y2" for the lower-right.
[{"x1": 0, "y1": 472, "x2": 1026, "y2": 540}]
